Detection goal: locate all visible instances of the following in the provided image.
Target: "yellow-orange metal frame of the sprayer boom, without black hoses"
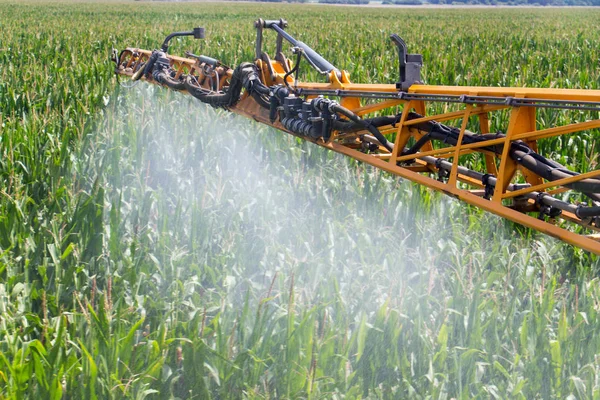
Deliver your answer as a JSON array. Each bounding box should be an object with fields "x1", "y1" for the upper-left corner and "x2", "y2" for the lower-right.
[{"x1": 118, "y1": 48, "x2": 600, "y2": 255}]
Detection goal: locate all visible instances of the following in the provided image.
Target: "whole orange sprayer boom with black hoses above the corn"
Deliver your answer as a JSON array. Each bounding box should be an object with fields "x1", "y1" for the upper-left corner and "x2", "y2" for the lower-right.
[{"x1": 114, "y1": 19, "x2": 600, "y2": 254}]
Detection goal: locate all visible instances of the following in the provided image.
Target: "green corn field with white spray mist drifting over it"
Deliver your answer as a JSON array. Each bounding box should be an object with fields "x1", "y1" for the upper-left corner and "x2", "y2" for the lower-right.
[{"x1": 0, "y1": 0, "x2": 600, "y2": 399}]
